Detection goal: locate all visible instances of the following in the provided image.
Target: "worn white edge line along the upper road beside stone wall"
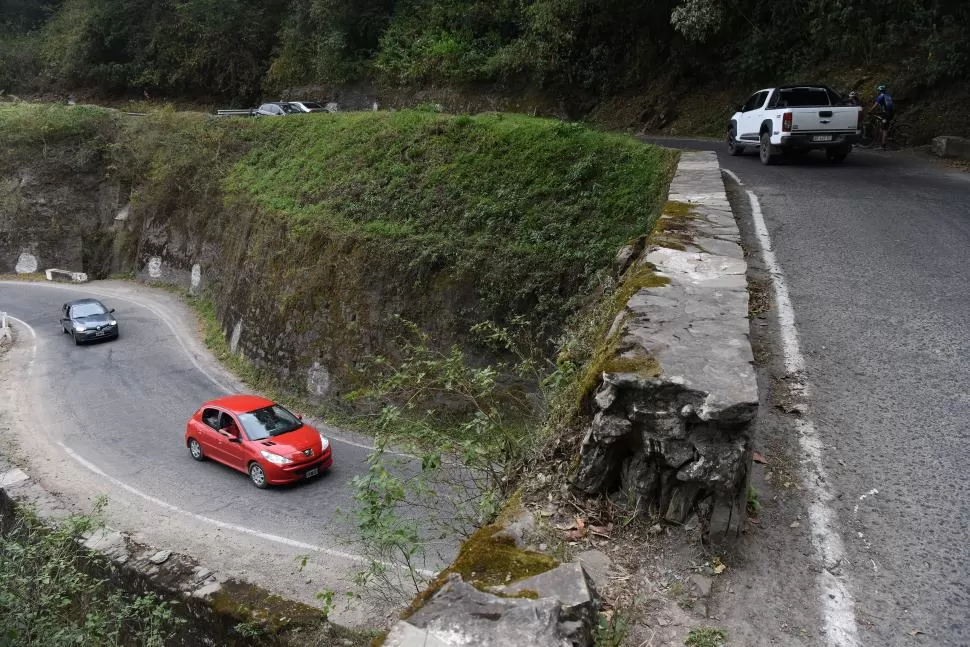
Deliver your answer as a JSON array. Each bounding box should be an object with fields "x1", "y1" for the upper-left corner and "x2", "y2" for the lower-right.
[{"x1": 747, "y1": 191, "x2": 860, "y2": 647}]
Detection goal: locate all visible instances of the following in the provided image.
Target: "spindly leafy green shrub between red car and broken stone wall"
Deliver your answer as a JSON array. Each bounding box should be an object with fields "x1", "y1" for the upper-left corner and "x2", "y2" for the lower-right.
[{"x1": 353, "y1": 320, "x2": 546, "y2": 600}]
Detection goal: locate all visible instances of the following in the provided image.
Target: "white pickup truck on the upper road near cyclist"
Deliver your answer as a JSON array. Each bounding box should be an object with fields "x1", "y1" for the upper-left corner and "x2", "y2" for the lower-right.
[{"x1": 728, "y1": 85, "x2": 862, "y2": 164}]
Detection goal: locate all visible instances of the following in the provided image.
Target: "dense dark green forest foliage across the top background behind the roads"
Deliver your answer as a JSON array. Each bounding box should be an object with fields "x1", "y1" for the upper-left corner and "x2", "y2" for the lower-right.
[{"x1": 0, "y1": 0, "x2": 970, "y2": 101}]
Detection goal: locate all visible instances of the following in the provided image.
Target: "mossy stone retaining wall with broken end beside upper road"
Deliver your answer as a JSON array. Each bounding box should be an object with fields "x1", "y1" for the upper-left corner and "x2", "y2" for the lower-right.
[{"x1": 574, "y1": 152, "x2": 758, "y2": 543}]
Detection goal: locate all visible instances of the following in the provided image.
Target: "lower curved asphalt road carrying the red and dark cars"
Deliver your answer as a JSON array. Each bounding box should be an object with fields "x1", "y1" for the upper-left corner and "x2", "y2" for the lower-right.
[{"x1": 0, "y1": 281, "x2": 442, "y2": 623}]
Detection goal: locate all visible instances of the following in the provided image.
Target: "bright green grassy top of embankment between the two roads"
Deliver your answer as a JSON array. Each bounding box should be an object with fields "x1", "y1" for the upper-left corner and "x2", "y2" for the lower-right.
[{"x1": 228, "y1": 111, "x2": 674, "y2": 344}]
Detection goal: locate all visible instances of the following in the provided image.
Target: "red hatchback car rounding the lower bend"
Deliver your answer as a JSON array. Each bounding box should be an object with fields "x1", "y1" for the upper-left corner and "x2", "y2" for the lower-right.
[{"x1": 185, "y1": 395, "x2": 333, "y2": 488}]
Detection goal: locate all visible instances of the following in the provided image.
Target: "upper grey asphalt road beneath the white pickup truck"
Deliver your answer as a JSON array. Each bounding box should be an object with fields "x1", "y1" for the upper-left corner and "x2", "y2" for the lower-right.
[{"x1": 651, "y1": 140, "x2": 970, "y2": 647}]
